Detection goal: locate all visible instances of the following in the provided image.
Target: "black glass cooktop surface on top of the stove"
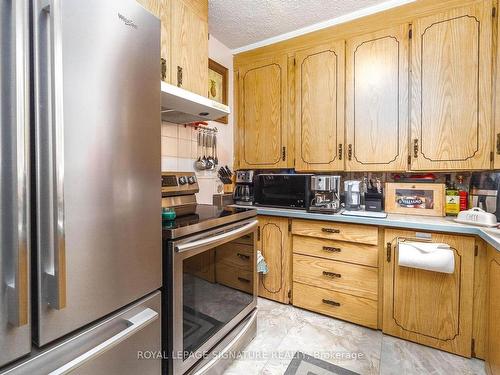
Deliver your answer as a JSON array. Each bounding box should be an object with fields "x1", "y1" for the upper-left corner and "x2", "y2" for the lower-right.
[{"x1": 163, "y1": 204, "x2": 257, "y2": 239}]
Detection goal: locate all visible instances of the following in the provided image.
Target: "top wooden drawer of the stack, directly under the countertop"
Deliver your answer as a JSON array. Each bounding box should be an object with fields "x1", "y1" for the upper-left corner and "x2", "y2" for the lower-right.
[{"x1": 292, "y1": 219, "x2": 378, "y2": 245}]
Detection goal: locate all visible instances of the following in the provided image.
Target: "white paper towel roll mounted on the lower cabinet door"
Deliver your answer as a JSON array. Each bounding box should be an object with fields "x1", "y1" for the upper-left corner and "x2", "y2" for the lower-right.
[{"x1": 398, "y1": 242, "x2": 455, "y2": 273}]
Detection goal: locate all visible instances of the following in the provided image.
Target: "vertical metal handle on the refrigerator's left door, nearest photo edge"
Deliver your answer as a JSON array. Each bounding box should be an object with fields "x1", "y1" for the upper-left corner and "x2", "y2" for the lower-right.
[{"x1": 6, "y1": 1, "x2": 29, "y2": 327}]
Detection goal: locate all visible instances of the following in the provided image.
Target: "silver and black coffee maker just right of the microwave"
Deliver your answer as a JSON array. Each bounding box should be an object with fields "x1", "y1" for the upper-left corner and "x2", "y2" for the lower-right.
[{"x1": 309, "y1": 175, "x2": 340, "y2": 214}]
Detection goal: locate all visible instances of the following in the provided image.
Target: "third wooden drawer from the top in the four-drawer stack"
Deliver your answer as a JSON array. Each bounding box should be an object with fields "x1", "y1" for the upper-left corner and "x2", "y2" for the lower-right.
[{"x1": 293, "y1": 254, "x2": 378, "y2": 301}]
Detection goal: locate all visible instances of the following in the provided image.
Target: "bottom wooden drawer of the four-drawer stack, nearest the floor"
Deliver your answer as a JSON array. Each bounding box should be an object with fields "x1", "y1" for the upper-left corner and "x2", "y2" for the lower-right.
[{"x1": 293, "y1": 283, "x2": 378, "y2": 329}]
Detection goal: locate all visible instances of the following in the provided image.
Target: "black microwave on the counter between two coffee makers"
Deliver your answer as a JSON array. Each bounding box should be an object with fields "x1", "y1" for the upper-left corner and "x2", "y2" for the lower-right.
[{"x1": 254, "y1": 174, "x2": 312, "y2": 210}]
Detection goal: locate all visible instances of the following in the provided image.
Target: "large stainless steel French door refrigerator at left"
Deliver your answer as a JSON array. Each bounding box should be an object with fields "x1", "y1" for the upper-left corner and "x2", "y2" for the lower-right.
[{"x1": 0, "y1": 0, "x2": 161, "y2": 374}]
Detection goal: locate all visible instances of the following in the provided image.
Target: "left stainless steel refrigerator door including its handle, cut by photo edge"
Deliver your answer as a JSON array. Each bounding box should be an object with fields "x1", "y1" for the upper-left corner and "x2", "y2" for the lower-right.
[{"x1": 0, "y1": 0, "x2": 31, "y2": 367}]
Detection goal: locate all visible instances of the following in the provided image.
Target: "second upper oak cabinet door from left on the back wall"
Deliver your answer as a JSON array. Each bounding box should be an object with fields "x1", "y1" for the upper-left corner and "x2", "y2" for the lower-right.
[{"x1": 295, "y1": 41, "x2": 345, "y2": 171}]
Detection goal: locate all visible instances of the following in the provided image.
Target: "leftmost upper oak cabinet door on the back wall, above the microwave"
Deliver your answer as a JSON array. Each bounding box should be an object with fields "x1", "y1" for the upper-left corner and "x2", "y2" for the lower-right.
[{"x1": 238, "y1": 55, "x2": 288, "y2": 169}]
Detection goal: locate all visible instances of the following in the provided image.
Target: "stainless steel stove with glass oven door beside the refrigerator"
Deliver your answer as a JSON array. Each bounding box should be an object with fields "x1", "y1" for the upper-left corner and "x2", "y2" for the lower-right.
[{"x1": 162, "y1": 172, "x2": 258, "y2": 375}]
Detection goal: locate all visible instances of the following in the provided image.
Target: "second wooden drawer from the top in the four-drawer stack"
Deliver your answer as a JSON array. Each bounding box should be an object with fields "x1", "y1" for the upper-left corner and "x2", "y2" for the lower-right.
[{"x1": 293, "y1": 236, "x2": 378, "y2": 267}]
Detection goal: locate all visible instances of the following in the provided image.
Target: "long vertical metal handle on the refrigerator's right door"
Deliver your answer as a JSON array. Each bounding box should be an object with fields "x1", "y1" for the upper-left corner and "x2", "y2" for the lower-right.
[{"x1": 38, "y1": 0, "x2": 66, "y2": 310}]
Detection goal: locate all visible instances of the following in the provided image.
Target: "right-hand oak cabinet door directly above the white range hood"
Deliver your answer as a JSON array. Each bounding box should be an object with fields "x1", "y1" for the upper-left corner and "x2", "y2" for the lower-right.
[{"x1": 171, "y1": 0, "x2": 208, "y2": 96}]
